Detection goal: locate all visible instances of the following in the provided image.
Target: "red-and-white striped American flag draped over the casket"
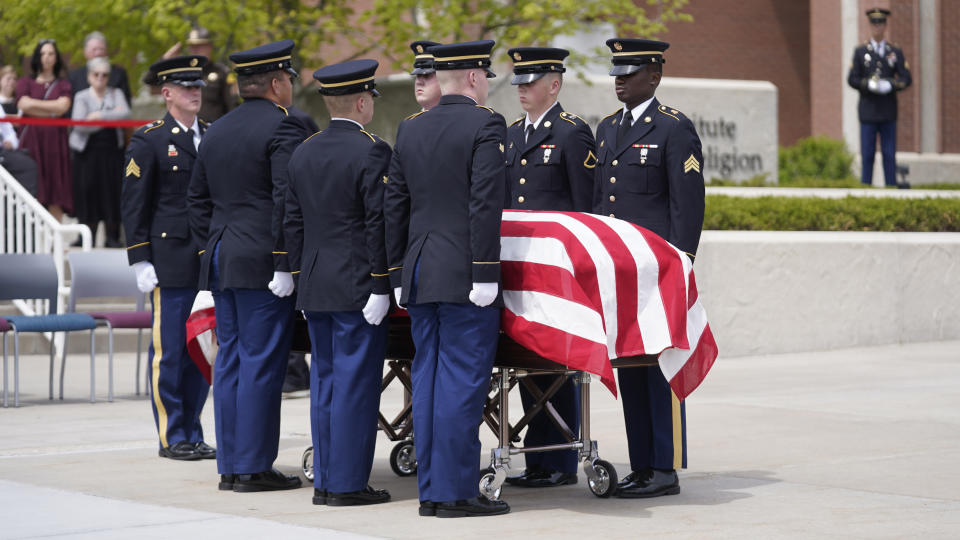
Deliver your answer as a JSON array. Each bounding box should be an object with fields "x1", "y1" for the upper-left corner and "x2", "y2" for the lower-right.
[{"x1": 187, "y1": 210, "x2": 717, "y2": 400}]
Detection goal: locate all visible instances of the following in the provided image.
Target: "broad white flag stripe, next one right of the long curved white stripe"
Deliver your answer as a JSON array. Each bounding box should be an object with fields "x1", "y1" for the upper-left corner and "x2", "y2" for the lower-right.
[{"x1": 601, "y1": 217, "x2": 686, "y2": 354}]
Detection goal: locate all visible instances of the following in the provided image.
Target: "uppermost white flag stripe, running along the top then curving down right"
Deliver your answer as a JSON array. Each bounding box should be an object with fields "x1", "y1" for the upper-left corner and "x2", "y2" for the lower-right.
[{"x1": 503, "y1": 212, "x2": 617, "y2": 358}]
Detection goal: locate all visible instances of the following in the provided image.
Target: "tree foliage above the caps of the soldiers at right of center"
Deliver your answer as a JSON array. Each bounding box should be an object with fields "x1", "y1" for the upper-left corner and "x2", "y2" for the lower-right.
[{"x1": 361, "y1": 0, "x2": 693, "y2": 71}]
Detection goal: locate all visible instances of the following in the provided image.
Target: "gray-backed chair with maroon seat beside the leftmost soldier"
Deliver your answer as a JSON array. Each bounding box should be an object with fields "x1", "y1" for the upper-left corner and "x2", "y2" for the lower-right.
[{"x1": 67, "y1": 249, "x2": 152, "y2": 401}]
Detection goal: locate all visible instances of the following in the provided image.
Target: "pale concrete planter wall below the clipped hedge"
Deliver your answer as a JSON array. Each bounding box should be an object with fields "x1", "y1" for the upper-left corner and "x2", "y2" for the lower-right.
[{"x1": 695, "y1": 231, "x2": 960, "y2": 358}]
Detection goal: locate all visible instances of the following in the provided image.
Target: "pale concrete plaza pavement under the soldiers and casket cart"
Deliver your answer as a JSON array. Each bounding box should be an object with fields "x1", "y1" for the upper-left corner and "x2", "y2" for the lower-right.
[{"x1": 0, "y1": 342, "x2": 960, "y2": 540}]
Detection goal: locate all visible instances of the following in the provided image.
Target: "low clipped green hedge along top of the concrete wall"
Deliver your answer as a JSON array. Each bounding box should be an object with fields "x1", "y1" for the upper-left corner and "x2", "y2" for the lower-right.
[{"x1": 703, "y1": 195, "x2": 960, "y2": 232}]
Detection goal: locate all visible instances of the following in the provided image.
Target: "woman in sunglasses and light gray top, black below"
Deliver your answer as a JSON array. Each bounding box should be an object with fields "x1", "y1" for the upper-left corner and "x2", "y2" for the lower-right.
[{"x1": 69, "y1": 56, "x2": 130, "y2": 247}]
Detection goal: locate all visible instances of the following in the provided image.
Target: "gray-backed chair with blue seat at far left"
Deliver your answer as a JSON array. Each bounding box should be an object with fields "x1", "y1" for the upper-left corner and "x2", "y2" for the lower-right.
[{"x1": 0, "y1": 253, "x2": 97, "y2": 407}]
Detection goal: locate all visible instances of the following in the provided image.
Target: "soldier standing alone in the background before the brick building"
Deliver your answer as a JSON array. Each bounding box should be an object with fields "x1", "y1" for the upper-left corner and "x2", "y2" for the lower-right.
[{"x1": 847, "y1": 8, "x2": 913, "y2": 186}]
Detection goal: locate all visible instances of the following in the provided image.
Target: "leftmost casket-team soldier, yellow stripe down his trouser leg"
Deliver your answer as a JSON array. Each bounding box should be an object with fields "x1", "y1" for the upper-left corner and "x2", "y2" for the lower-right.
[{"x1": 120, "y1": 56, "x2": 217, "y2": 460}]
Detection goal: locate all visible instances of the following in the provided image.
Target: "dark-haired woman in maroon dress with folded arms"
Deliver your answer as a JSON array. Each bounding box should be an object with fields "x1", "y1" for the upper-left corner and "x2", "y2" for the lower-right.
[{"x1": 16, "y1": 39, "x2": 73, "y2": 221}]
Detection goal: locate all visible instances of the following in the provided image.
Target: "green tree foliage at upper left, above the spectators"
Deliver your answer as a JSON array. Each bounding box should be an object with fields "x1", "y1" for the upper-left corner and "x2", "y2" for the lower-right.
[{"x1": 0, "y1": 0, "x2": 354, "y2": 90}]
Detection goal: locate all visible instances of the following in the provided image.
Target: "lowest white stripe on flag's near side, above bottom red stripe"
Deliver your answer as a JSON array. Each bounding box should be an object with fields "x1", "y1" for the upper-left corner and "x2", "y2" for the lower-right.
[{"x1": 503, "y1": 291, "x2": 607, "y2": 345}]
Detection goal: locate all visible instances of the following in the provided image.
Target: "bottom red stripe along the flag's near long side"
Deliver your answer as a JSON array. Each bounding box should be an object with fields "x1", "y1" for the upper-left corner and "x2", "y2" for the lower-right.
[{"x1": 500, "y1": 309, "x2": 617, "y2": 396}]
